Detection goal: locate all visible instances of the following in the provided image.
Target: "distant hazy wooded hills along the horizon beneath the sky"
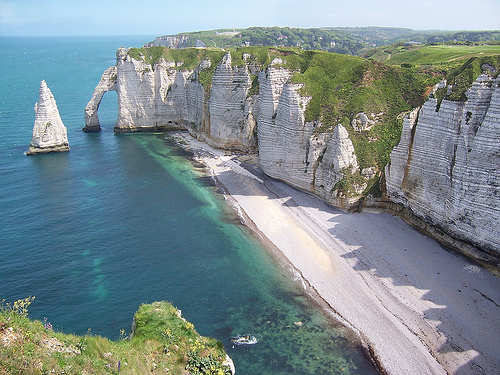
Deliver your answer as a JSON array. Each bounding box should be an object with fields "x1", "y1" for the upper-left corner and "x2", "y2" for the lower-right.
[{"x1": 150, "y1": 27, "x2": 500, "y2": 55}]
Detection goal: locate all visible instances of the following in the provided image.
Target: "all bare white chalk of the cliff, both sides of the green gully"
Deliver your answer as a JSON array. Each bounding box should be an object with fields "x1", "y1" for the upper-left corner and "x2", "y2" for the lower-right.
[{"x1": 84, "y1": 48, "x2": 500, "y2": 261}]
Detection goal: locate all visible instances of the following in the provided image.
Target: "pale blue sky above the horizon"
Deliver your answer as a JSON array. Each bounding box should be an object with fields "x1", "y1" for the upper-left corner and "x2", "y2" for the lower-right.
[{"x1": 0, "y1": 0, "x2": 500, "y2": 36}]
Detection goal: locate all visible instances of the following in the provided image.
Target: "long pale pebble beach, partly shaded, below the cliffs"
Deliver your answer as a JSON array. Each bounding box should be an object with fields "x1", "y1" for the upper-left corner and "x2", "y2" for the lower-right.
[{"x1": 176, "y1": 134, "x2": 500, "y2": 375}]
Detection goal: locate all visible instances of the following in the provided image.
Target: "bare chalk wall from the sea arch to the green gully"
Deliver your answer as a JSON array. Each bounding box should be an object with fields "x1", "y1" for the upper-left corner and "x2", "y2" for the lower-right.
[{"x1": 84, "y1": 48, "x2": 364, "y2": 201}]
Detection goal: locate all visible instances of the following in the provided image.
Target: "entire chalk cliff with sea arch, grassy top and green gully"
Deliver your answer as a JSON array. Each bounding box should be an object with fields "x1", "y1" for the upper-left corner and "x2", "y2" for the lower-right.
[{"x1": 84, "y1": 47, "x2": 500, "y2": 268}]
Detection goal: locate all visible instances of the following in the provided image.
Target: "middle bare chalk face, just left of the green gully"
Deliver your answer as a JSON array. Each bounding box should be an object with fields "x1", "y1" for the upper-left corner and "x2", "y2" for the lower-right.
[{"x1": 258, "y1": 59, "x2": 358, "y2": 207}]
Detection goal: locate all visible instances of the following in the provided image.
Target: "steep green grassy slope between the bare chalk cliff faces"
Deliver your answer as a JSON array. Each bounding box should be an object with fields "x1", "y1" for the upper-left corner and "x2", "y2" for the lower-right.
[{"x1": 293, "y1": 51, "x2": 439, "y2": 170}]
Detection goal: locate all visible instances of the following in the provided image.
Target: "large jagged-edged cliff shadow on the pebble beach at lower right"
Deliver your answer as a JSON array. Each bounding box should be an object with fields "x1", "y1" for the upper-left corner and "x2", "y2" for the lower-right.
[{"x1": 329, "y1": 213, "x2": 500, "y2": 375}]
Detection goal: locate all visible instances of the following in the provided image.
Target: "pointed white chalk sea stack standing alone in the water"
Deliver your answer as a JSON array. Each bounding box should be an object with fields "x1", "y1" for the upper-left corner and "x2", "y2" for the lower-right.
[{"x1": 26, "y1": 80, "x2": 69, "y2": 155}]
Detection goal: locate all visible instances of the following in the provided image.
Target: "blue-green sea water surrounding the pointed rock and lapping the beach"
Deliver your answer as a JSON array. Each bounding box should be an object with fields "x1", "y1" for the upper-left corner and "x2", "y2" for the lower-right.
[{"x1": 0, "y1": 37, "x2": 375, "y2": 374}]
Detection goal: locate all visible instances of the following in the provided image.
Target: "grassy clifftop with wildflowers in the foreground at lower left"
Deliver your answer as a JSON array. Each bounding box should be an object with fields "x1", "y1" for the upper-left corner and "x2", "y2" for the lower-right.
[{"x1": 0, "y1": 297, "x2": 230, "y2": 375}]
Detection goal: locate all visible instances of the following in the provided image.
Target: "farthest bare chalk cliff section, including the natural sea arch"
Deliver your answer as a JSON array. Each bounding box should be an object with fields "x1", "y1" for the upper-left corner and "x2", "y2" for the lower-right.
[{"x1": 83, "y1": 48, "x2": 257, "y2": 151}]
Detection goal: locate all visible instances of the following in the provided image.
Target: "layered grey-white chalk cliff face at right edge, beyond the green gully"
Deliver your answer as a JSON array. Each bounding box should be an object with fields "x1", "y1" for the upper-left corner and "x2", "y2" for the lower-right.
[{"x1": 386, "y1": 75, "x2": 500, "y2": 256}]
